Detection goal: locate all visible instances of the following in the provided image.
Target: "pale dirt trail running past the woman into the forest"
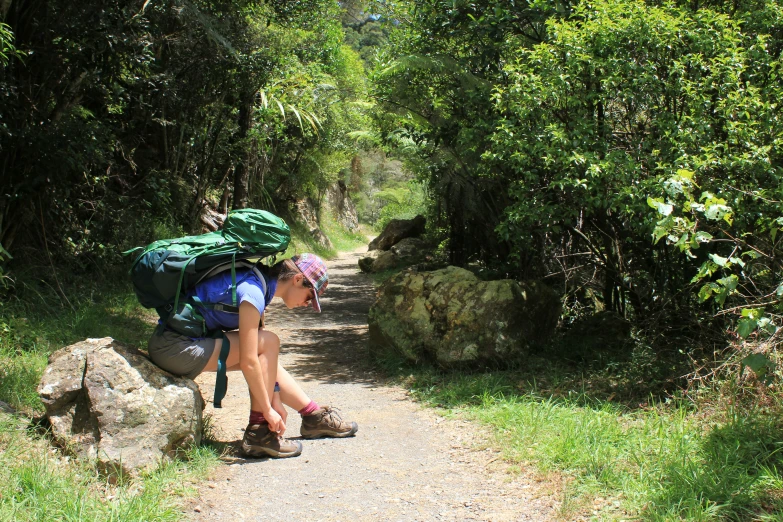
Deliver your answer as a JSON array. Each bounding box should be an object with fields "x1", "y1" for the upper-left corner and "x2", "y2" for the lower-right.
[{"x1": 186, "y1": 248, "x2": 557, "y2": 521}]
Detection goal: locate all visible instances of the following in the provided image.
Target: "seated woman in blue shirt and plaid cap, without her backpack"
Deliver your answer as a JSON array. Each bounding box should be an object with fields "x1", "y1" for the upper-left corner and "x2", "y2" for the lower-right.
[{"x1": 149, "y1": 254, "x2": 358, "y2": 458}]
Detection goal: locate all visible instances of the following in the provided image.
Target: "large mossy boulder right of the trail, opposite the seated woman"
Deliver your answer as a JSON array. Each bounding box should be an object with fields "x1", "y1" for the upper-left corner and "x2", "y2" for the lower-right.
[{"x1": 369, "y1": 266, "x2": 560, "y2": 368}]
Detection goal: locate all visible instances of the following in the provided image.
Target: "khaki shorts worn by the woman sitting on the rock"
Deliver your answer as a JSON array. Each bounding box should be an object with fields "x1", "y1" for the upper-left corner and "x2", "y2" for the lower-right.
[{"x1": 147, "y1": 328, "x2": 216, "y2": 379}]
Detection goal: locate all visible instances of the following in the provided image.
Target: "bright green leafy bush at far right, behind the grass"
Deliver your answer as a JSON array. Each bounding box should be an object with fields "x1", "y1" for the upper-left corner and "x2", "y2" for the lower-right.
[{"x1": 494, "y1": 1, "x2": 783, "y2": 334}]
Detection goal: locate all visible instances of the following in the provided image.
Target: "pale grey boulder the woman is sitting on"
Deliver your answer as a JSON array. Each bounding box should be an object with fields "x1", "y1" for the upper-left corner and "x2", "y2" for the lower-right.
[{"x1": 38, "y1": 337, "x2": 204, "y2": 473}]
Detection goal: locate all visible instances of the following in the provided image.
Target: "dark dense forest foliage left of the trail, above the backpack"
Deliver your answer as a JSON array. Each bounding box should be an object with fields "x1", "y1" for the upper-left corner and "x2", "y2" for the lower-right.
[{"x1": 0, "y1": 0, "x2": 366, "y2": 264}]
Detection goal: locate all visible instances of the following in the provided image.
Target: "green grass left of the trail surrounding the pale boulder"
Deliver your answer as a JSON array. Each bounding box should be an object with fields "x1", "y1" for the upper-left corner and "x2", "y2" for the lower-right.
[{"x1": 0, "y1": 270, "x2": 218, "y2": 522}]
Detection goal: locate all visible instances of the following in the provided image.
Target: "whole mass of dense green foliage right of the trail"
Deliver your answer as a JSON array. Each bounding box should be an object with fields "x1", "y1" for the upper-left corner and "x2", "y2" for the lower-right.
[{"x1": 375, "y1": 0, "x2": 783, "y2": 350}]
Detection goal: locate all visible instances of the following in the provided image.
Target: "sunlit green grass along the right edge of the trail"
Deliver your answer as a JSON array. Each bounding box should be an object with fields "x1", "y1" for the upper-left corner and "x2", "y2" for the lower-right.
[{"x1": 388, "y1": 360, "x2": 783, "y2": 521}]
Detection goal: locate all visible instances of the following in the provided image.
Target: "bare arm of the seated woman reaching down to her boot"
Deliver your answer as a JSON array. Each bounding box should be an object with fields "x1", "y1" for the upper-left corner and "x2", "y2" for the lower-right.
[{"x1": 239, "y1": 302, "x2": 285, "y2": 432}]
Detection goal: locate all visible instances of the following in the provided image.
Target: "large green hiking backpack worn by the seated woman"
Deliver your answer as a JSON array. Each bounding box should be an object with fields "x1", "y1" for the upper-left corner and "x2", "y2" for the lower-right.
[{"x1": 125, "y1": 208, "x2": 291, "y2": 408}]
